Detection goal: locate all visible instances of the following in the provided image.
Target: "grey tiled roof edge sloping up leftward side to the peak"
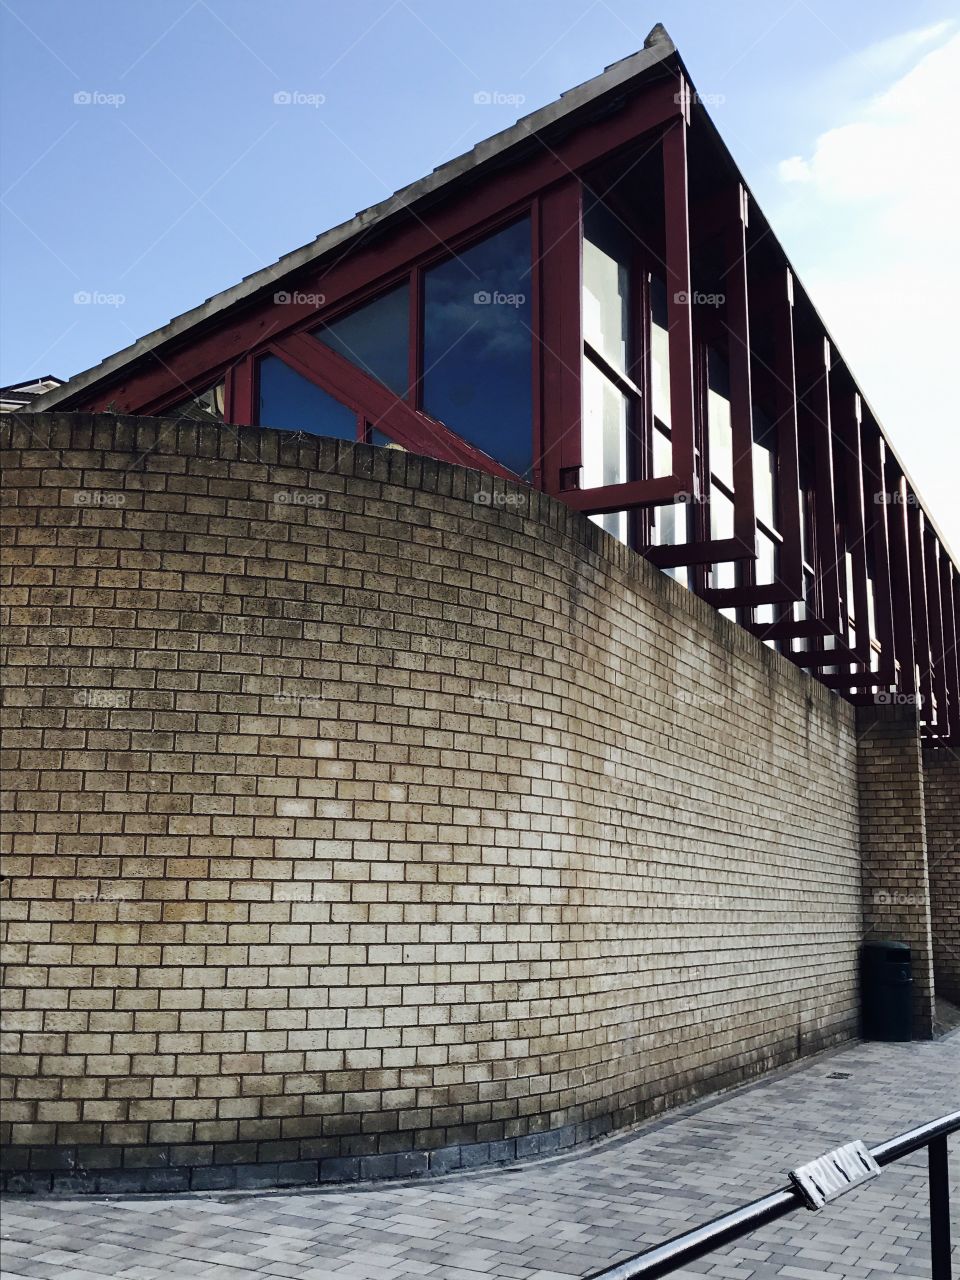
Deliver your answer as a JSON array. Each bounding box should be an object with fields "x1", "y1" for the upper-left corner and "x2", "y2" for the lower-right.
[{"x1": 33, "y1": 23, "x2": 677, "y2": 412}]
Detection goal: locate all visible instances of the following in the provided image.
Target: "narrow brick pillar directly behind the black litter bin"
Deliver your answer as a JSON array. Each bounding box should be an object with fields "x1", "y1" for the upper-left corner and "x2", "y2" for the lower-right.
[{"x1": 856, "y1": 704, "x2": 933, "y2": 1039}]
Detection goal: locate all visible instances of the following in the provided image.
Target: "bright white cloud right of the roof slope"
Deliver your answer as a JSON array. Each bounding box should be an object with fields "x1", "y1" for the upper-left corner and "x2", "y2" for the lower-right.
[{"x1": 774, "y1": 24, "x2": 960, "y2": 550}]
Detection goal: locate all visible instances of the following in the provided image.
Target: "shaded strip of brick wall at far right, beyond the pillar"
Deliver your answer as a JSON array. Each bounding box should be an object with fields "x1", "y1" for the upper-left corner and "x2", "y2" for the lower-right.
[{"x1": 923, "y1": 748, "x2": 960, "y2": 1004}]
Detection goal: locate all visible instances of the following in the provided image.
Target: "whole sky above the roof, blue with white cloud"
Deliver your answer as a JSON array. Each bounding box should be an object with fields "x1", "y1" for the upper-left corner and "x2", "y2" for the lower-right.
[{"x1": 0, "y1": 0, "x2": 960, "y2": 547}]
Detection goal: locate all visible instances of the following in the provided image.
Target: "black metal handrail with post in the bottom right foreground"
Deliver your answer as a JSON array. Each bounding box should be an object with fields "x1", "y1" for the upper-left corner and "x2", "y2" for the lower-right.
[{"x1": 586, "y1": 1111, "x2": 960, "y2": 1280}]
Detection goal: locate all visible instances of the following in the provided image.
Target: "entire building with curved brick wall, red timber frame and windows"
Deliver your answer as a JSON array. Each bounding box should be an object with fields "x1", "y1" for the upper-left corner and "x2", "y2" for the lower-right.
[{"x1": 4, "y1": 27, "x2": 960, "y2": 1190}]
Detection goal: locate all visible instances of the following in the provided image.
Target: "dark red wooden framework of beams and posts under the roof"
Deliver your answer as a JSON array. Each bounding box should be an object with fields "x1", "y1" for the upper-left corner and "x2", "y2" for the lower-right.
[{"x1": 54, "y1": 64, "x2": 960, "y2": 742}]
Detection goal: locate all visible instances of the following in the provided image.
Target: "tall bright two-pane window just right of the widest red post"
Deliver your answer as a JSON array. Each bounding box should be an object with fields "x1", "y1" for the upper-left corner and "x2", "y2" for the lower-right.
[{"x1": 582, "y1": 201, "x2": 640, "y2": 543}]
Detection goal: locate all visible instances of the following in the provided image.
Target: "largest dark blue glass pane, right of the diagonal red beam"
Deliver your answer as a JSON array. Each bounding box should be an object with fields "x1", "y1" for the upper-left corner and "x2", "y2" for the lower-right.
[{"x1": 424, "y1": 218, "x2": 532, "y2": 476}]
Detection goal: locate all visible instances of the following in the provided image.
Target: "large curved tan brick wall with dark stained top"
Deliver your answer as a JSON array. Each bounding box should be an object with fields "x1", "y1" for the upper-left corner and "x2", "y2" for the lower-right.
[{"x1": 1, "y1": 415, "x2": 861, "y2": 1190}]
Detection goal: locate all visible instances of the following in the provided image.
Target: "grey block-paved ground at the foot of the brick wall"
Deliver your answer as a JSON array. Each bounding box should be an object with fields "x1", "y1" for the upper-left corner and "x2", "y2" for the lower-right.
[{"x1": 0, "y1": 1033, "x2": 960, "y2": 1280}]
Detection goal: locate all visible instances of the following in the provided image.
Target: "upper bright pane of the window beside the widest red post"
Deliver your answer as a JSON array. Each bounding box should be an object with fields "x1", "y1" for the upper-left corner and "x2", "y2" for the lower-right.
[{"x1": 584, "y1": 204, "x2": 630, "y2": 372}]
